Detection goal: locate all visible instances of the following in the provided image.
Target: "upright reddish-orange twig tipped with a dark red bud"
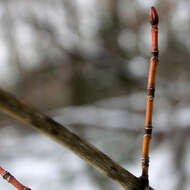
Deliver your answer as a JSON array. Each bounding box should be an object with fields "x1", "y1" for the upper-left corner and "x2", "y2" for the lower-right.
[{"x1": 142, "y1": 7, "x2": 159, "y2": 187}]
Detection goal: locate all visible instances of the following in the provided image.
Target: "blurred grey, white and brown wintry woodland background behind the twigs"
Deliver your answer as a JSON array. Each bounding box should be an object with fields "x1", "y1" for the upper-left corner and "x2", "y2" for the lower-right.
[{"x1": 0, "y1": 0, "x2": 190, "y2": 190}]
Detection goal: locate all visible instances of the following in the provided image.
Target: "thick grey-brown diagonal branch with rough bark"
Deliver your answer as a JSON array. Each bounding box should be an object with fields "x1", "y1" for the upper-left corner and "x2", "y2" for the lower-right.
[{"x1": 0, "y1": 89, "x2": 153, "y2": 190}]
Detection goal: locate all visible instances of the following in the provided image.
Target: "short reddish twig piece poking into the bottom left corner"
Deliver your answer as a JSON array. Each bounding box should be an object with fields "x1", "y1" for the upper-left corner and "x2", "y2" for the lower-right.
[{"x1": 0, "y1": 167, "x2": 31, "y2": 190}]
